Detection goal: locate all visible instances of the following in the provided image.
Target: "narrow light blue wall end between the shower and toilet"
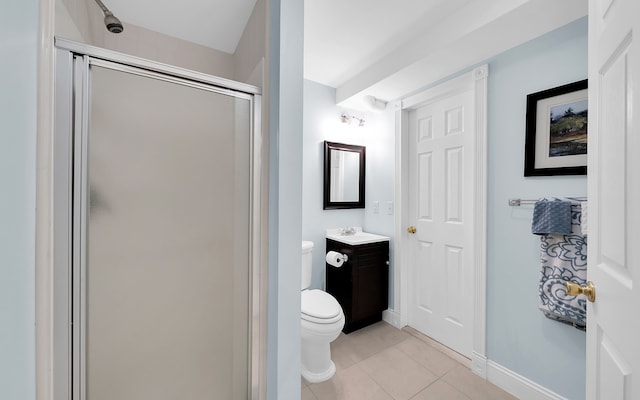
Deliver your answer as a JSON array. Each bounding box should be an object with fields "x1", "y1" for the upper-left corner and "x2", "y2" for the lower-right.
[{"x1": 267, "y1": 0, "x2": 304, "y2": 400}]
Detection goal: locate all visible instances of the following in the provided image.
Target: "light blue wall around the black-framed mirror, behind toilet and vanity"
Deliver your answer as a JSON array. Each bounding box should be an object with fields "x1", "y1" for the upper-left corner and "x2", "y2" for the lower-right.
[{"x1": 302, "y1": 80, "x2": 395, "y2": 305}]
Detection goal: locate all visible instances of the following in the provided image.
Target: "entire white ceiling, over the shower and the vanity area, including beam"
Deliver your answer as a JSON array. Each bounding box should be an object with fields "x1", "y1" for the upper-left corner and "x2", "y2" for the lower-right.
[{"x1": 104, "y1": 0, "x2": 588, "y2": 109}]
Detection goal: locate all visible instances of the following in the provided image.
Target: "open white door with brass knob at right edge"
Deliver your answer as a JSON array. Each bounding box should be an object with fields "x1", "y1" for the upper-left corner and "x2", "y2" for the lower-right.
[{"x1": 587, "y1": 0, "x2": 640, "y2": 400}]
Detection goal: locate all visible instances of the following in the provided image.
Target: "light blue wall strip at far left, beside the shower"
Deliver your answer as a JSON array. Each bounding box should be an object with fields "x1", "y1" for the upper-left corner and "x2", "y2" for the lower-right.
[{"x1": 0, "y1": 0, "x2": 38, "y2": 400}]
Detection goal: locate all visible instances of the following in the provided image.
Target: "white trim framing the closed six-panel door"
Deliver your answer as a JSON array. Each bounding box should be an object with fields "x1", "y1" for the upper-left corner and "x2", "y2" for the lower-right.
[{"x1": 389, "y1": 64, "x2": 489, "y2": 379}]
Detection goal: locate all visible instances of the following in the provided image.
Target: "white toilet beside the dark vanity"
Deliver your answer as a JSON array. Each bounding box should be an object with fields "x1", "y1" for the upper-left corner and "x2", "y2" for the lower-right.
[{"x1": 300, "y1": 241, "x2": 344, "y2": 383}]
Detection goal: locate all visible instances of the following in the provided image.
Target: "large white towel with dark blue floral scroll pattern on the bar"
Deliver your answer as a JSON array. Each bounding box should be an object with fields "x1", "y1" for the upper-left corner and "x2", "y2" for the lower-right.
[{"x1": 538, "y1": 205, "x2": 587, "y2": 330}]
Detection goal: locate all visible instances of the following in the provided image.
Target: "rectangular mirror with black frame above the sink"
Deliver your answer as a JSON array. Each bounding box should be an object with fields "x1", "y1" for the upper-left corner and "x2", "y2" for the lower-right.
[{"x1": 323, "y1": 141, "x2": 365, "y2": 210}]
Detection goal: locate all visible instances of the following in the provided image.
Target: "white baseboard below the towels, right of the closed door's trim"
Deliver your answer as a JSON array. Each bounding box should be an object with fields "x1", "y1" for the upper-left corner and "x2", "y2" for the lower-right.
[{"x1": 488, "y1": 360, "x2": 567, "y2": 400}]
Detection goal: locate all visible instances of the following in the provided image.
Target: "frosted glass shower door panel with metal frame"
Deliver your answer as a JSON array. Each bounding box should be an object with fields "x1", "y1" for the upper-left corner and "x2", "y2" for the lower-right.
[{"x1": 73, "y1": 62, "x2": 252, "y2": 400}]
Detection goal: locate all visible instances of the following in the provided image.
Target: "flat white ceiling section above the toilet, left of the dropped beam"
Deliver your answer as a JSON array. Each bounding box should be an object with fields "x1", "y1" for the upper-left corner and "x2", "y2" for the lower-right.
[{"x1": 304, "y1": 0, "x2": 472, "y2": 87}]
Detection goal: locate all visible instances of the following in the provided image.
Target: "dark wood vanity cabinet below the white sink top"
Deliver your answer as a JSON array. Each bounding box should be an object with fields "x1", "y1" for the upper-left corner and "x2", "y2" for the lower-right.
[{"x1": 326, "y1": 239, "x2": 389, "y2": 333}]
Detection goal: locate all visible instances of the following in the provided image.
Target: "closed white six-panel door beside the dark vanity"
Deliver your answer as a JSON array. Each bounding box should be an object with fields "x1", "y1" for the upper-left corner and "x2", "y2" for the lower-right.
[{"x1": 408, "y1": 77, "x2": 476, "y2": 358}]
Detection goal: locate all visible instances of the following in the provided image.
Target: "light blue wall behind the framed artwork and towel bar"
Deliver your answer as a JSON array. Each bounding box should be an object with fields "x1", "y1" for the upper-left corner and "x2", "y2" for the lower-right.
[{"x1": 487, "y1": 18, "x2": 587, "y2": 400}]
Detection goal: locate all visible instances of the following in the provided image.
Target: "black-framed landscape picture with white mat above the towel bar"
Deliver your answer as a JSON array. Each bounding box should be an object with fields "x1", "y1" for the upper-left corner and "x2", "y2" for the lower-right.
[{"x1": 524, "y1": 79, "x2": 588, "y2": 176}]
